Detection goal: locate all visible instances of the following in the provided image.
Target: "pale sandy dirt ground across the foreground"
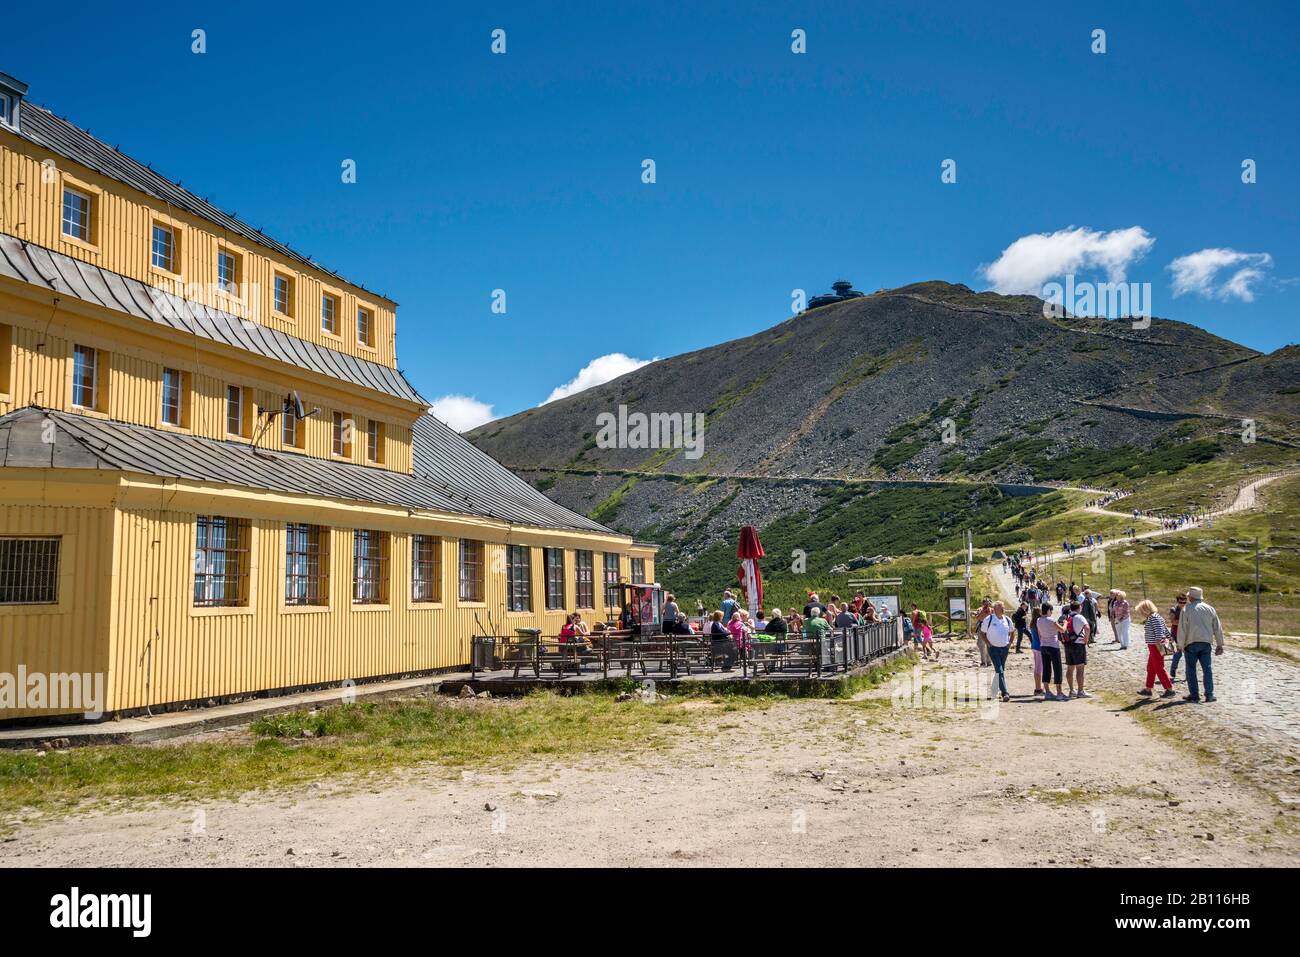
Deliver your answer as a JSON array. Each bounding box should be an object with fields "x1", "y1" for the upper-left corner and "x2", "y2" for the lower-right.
[{"x1": 0, "y1": 641, "x2": 1300, "y2": 866}]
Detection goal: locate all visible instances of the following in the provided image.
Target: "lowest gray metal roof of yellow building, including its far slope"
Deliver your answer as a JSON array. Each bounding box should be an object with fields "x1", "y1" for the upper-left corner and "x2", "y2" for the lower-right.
[{"x1": 0, "y1": 406, "x2": 618, "y2": 534}]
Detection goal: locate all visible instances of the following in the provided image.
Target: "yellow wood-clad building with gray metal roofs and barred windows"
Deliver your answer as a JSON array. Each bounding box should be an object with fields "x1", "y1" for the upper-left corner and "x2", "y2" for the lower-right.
[{"x1": 0, "y1": 74, "x2": 655, "y2": 722}]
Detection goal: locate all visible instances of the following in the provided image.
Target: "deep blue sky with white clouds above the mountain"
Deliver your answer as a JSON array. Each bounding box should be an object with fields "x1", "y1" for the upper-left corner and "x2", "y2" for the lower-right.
[{"x1": 0, "y1": 0, "x2": 1300, "y2": 428}]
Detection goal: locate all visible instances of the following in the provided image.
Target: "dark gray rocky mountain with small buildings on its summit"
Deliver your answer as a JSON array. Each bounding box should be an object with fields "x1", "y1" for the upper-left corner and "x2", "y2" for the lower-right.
[{"x1": 468, "y1": 281, "x2": 1300, "y2": 595}]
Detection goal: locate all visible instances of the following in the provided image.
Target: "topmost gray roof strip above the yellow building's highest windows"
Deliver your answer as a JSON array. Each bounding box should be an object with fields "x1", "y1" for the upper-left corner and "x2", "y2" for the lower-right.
[{"x1": 17, "y1": 100, "x2": 391, "y2": 302}]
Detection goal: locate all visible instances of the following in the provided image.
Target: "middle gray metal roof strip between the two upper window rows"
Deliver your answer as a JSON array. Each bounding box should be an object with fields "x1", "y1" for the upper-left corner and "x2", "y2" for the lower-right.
[{"x1": 0, "y1": 234, "x2": 429, "y2": 406}]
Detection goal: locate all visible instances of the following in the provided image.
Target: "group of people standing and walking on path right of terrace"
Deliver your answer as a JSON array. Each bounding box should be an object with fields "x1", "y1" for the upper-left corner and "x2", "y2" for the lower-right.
[{"x1": 998, "y1": 555, "x2": 1225, "y2": 702}]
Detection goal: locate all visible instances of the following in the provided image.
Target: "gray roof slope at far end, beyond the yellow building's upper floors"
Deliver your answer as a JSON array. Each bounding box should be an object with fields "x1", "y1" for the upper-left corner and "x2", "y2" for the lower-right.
[{"x1": 411, "y1": 415, "x2": 618, "y2": 534}]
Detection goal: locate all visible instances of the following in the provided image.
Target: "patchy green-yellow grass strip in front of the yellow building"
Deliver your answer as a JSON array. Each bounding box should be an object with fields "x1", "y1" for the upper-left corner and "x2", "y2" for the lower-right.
[{"x1": 0, "y1": 692, "x2": 767, "y2": 813}]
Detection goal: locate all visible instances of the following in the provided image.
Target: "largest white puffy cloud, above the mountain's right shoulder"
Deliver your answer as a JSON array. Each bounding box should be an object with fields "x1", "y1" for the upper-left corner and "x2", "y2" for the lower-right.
[{"x1": 982, "y1": 226, "x2": 1156, "y2": 295}]
